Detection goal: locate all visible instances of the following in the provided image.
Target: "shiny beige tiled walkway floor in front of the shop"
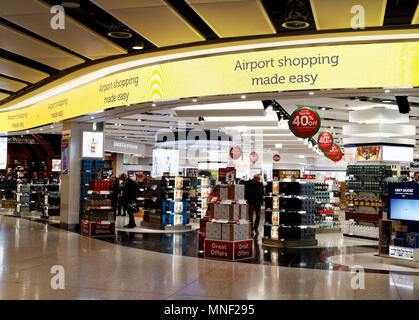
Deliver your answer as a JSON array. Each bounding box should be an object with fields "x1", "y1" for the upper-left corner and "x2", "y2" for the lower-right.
[{"x1": 0, "y1": 216, "x2": 419, "y2": 299}]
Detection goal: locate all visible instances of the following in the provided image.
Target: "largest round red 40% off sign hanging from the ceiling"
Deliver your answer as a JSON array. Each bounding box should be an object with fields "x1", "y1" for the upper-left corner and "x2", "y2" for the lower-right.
[{"x1": 288, "y1": 107, "x2": 321, "y2": 138}]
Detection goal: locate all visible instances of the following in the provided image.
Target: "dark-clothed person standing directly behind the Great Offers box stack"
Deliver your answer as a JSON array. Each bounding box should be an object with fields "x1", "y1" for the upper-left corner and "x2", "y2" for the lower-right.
[{"x1": 245, "y1": 174, "x2": 263, "y2": 235}]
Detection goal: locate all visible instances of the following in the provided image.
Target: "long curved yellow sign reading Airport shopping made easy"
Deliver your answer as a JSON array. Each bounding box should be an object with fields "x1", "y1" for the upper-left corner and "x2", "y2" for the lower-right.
[{"x1": 0, "y1": 42, "x2": 419, "y2": 132}]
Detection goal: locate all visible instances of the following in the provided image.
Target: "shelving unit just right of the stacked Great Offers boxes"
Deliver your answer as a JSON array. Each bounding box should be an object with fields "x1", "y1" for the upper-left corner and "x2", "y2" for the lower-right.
[{"x1": 262, "y1": 181, "x2": 317, "y2": 248}]
